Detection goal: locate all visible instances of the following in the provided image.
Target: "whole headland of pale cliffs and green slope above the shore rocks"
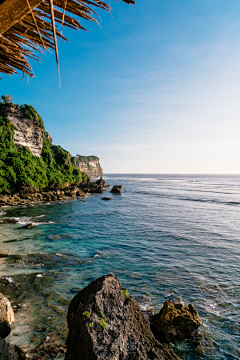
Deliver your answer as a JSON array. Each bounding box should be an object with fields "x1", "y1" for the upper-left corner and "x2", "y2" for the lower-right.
[{"x1": 0, "y1": 95, "x2": 102, "y2": 197}]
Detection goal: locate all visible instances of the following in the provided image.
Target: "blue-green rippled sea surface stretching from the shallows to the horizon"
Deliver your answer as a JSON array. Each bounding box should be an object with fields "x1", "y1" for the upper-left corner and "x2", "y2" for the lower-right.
[{"x1": 0, "y1": 174, "x2": 240, "y2": 360}]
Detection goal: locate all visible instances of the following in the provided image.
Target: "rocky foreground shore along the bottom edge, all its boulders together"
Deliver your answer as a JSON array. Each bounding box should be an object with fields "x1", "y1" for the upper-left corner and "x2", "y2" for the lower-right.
[{"x1": 0, "y1": 274, "x2": 202, "y2": 360}]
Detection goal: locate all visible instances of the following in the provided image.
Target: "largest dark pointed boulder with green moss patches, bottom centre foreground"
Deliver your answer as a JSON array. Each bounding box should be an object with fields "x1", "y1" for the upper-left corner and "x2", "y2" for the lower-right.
[{"x1": 65, "y1": 274, "x2": 180, "y2": 360}]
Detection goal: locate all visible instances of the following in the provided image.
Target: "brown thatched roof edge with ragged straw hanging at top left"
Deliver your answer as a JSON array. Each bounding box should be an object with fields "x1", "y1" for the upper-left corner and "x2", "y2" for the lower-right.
[{"x1": 0, "y1": 0, "x2": 135, "y2": 76}]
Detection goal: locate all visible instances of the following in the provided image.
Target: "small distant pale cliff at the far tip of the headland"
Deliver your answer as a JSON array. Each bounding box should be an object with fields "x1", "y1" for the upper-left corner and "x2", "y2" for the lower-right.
[{"x1": 72, "y1": 155, "x2": 103, "y2": 178}]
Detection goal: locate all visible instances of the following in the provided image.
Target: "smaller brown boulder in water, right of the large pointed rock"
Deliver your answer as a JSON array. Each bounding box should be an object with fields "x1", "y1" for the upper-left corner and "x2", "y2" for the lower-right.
[{"x1": 151, "y1": 300, "x2": 202, "y2": 342}]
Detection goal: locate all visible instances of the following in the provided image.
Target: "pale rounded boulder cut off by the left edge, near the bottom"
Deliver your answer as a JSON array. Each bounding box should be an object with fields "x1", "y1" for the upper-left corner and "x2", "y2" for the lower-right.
[{"x1": 0, "y1": 293, "x2": 14, "y2": 338}]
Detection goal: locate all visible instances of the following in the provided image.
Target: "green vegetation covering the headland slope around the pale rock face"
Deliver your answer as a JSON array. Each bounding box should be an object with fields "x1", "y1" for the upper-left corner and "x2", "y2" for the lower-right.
[{"x1": 0, "y1": 95, "x2": 89, "y2": 193}]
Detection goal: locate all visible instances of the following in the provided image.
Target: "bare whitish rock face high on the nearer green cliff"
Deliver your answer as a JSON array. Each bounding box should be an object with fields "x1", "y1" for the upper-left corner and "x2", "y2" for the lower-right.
[{"x1": 0, "y1": 108, "x2": 43, "y2": 157}]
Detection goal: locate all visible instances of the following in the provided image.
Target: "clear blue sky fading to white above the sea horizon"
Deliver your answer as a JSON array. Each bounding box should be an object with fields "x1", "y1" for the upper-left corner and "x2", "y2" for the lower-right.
[{"x1": 0, "y1": 0, "x2": 240, "y2": 174}]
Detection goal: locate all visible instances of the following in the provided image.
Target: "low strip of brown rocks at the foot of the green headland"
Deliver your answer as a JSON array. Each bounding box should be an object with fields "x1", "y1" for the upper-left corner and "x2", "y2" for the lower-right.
[{"x1": 0, "y1": 178, "x2": 109, "y2": 207}]
